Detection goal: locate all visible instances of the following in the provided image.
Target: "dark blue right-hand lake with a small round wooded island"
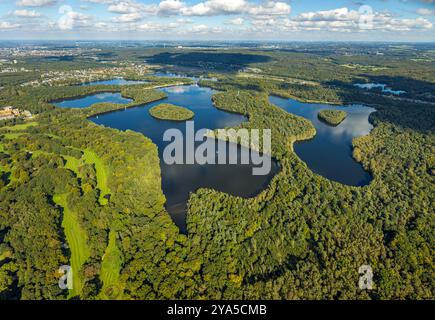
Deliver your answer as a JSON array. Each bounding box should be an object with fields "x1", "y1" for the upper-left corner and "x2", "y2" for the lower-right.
[{"x1": 269, "y1": 96, "x2": 375, "y2": 186}]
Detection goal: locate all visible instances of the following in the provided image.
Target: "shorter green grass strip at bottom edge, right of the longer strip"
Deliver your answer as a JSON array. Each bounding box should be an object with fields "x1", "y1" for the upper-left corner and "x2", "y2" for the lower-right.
[{"x1": 100, "y1": 231, "x2": 124, "y2": 299}]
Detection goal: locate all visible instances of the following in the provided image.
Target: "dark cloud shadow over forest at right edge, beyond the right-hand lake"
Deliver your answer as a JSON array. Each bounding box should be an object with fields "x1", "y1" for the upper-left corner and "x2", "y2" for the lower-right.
[{"x1": 326, "y1": 74, "x2": 435, "y2": 133}]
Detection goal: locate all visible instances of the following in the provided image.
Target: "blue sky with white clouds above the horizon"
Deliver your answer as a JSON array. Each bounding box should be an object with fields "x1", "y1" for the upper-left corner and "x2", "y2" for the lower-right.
[{"x1": 0, "y1": 0, "x2": 435, "y2": 42}]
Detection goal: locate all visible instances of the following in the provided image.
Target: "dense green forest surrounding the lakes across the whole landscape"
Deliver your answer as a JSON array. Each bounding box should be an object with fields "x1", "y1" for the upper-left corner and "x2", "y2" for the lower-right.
[{"x1": 0, "y1": 49, "x2": 435, "y2": 299}]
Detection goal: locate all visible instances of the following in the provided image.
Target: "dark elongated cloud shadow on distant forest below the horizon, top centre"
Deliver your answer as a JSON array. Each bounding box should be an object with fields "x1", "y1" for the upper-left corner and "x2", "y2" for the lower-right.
[{"x1": 144, "y1": 52, "x2": 272, "y2": 71}]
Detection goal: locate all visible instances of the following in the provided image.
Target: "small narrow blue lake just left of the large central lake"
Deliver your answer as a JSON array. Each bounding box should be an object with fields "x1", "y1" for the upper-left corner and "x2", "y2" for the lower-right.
[{"x1": 52, "y1": 92, "x2": 133, "y2": 108}]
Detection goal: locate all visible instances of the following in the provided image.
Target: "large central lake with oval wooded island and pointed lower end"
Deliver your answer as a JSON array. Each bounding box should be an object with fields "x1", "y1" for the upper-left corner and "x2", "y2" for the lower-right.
[{"x1": 86, "y1": 85, "x2": 280, "y2": 232}]
